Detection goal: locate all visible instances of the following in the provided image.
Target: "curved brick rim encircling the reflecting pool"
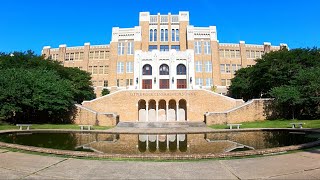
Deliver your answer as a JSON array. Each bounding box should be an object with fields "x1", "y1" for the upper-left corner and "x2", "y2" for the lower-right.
[{"x1": 0, "y1": 128, "x2": 320, "y2": 160}]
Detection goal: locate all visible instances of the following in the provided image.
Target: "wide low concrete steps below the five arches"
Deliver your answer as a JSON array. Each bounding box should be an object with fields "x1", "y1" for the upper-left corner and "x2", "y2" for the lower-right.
[{"x1": 117, "y1": 122, "x2": 206, "y2": 128}]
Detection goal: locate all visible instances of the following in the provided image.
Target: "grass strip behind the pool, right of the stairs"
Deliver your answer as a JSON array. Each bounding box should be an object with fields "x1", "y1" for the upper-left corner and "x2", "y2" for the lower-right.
[{"x1": 209, "y1": 120, "x2": 320, "y2": 129}]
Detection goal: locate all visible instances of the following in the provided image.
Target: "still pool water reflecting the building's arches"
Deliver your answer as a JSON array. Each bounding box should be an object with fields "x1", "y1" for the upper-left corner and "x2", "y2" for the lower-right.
[{"x1": 0, "y1": 130, "x2": 320, "y2": 154}]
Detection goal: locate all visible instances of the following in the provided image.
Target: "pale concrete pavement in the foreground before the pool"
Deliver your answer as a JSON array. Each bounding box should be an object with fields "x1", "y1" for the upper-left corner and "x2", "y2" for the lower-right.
[{"x1": 0, "y1": 149, "x2": 320, "y2": 179}]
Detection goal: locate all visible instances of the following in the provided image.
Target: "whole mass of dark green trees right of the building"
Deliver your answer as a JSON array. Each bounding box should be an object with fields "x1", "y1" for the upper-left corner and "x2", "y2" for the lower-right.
[{"x1": 229, "y1": 48, "x2": 320, "y2": 119}]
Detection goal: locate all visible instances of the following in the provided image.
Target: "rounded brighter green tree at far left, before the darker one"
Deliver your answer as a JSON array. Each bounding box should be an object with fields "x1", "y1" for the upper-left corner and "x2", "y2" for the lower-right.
[{"x1": 0, "y1": 68, "x2": 74, "y2": 122}]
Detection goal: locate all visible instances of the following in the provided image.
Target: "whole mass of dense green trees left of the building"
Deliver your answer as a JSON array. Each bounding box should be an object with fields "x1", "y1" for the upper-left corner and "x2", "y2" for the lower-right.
[{"x1": 0, "y1": 51, "x2": 95, "y2": 123}]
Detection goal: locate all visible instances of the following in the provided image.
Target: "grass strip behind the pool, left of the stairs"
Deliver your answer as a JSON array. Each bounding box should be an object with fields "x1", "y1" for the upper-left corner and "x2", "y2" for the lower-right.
[{"x1": 0, "y1": 123, "x2": 110, "y2": 130}]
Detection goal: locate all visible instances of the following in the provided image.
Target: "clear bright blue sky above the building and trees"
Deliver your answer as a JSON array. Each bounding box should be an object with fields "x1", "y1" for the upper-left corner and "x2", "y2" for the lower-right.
[{"x1": 0, "y1": 0, "x2": 320, "y2": 54}]
